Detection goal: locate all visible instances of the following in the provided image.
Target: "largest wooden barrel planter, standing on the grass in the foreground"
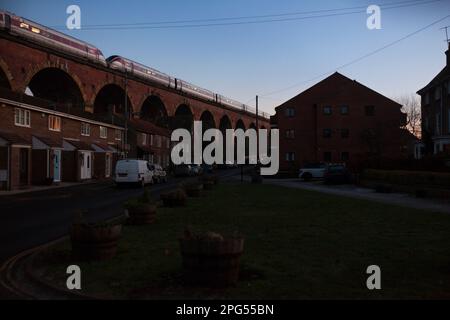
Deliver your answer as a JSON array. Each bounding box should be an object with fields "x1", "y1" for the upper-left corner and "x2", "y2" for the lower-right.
[{"x1": 180, "y1": 238, "x2": 244, "y2": 287}]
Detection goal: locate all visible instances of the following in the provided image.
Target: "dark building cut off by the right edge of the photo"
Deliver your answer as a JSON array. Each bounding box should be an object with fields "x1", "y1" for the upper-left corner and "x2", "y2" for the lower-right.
[{"x1": 417, "y1": 43, "x2": 450, "y2": 154}]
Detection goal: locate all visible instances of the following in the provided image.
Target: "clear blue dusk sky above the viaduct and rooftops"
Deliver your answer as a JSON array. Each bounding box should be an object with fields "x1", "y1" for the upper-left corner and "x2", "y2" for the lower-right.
[{"x1": 0, "y1": 0, "x2": 450, "y2": 114}]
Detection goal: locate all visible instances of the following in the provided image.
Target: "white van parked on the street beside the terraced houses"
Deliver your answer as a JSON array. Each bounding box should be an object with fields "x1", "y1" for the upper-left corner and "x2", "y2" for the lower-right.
[{"x1": 114, "y1": 159, "x2": 153, "y2": 186}]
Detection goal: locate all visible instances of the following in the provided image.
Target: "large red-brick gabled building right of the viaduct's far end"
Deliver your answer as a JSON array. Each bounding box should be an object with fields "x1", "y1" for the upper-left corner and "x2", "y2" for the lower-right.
[{"x1": 271, "y1": 72, "x2": 407, "y2": 170}]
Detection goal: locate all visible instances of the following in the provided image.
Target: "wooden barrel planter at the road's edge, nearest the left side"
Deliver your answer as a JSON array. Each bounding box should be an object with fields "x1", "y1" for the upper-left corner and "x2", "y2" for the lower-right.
[{"x1": 70, "y1": 224, "x2": 122, "y2": 261}]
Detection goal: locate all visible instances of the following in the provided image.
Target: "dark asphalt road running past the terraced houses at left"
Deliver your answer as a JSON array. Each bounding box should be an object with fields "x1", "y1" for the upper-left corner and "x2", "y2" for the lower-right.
[{"x1": 0, "y1": 169, "x2": 240, "y2": 265}]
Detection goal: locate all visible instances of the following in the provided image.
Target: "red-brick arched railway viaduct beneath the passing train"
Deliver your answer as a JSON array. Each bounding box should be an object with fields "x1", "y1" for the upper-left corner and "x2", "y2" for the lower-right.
[{"x1": 0, "y1": 34, "x2": 270, "y2": 129}]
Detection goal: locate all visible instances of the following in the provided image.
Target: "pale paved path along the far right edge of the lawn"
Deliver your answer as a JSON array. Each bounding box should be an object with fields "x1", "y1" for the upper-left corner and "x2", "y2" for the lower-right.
[{"x1": 264, "y1": 179, "x2": 450, "y2": 213}]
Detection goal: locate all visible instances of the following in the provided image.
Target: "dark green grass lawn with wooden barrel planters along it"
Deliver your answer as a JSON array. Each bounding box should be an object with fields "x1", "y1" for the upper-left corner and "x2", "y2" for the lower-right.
[{"x1": 39, "y1": 184, "x2": 450, "y2": 299}]
